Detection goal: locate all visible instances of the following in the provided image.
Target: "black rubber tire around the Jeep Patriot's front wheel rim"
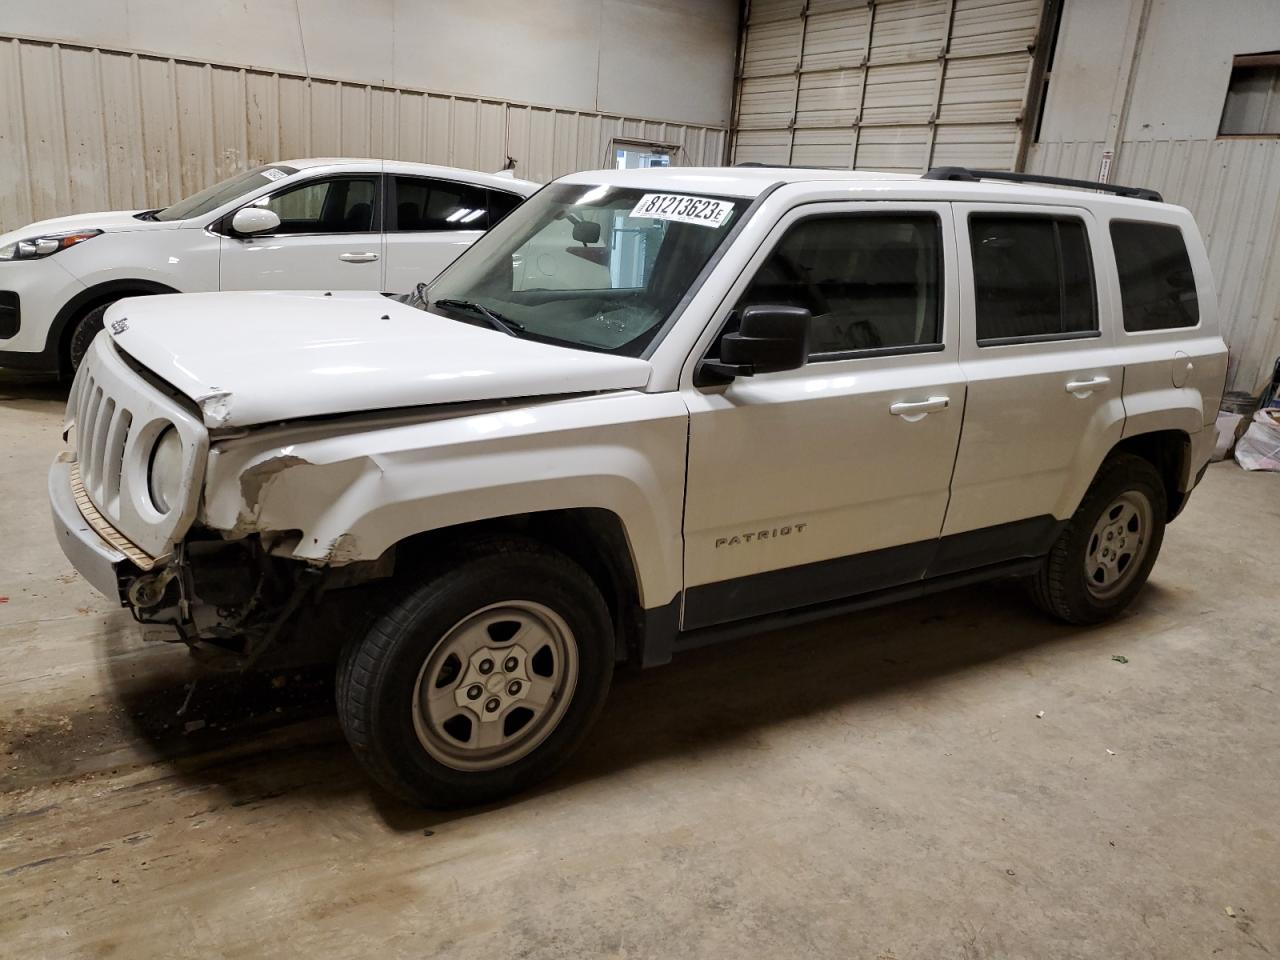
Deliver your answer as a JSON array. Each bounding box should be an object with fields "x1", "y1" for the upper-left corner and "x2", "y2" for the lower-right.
[{"x1": 337, "y1": 539, "x2": 614, "y2": 808}]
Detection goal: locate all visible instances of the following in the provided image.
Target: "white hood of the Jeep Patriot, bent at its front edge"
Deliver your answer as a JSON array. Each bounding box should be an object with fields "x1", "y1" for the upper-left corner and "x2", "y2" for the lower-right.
[{"x1": 105, "y1": 291, "x2": 650, "y2": 428}]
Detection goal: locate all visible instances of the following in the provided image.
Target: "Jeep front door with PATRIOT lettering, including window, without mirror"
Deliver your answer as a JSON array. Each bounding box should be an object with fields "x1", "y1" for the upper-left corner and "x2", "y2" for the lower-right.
[{"x1": 682, "y1": 202, "x2": 965, "y2": 630}]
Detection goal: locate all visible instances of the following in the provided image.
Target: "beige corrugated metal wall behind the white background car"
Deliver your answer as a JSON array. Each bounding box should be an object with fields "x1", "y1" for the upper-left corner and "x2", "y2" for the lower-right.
[{"x1": 0, "y1": 37, "x2": 727, "y2": 230}]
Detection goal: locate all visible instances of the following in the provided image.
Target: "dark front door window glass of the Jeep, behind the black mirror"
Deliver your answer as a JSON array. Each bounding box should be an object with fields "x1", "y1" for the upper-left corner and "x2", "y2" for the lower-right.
[{"x1": 737, "y1": 212, "x2": 942, "y2": 360}]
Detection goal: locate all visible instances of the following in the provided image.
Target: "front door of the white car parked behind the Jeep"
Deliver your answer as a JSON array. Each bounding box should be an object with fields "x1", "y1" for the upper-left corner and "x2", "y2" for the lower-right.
[{"x1": 219, "y1": 173, "x2": 383, "y2": 291}]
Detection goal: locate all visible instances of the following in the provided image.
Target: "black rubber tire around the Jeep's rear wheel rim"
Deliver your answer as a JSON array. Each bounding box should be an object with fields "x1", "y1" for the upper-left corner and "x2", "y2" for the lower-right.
[{"x1": 1029, "y1": 453, "x2": 1169, "y2": 623}]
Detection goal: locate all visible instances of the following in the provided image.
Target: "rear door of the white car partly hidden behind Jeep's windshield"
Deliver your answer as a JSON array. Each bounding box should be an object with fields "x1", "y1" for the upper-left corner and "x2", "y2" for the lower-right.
[{"x1": 385, "y1": 175, "x2": 513, "y2": 293}]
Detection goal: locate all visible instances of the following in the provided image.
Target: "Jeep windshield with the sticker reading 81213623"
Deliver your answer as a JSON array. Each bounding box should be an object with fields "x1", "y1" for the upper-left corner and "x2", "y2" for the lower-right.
[{"x1": 424, "y1": 184, "x2": 749, "y2": 357}]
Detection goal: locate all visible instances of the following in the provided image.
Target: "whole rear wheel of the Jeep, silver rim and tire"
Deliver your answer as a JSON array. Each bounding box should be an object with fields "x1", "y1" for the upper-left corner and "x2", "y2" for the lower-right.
[{"x1": 1030, "y1": 453, "x2": 1167, "y2": 623}]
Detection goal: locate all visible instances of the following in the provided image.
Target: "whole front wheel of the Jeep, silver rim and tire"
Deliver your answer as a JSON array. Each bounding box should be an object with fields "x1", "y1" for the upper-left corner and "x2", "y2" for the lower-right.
[{"x1": 337, "y1": 539, "x2": 614, "y2": 806}]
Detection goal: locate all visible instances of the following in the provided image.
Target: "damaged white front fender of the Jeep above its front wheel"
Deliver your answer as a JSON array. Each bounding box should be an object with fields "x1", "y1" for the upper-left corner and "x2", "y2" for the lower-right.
[{"x1": 201, "y1": 392, "x2": 689, "y2": 607}]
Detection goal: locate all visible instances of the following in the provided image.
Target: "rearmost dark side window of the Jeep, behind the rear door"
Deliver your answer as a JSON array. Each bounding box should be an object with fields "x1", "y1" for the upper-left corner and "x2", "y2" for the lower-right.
[{"x1": 1111, "y1": 220, "x2": 1199, "y2": 333}]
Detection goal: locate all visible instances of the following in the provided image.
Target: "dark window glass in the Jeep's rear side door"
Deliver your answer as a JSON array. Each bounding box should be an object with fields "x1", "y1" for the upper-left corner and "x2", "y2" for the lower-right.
[{"x1": 969, "y1": 214, "x2": 1098, "y2": 346}]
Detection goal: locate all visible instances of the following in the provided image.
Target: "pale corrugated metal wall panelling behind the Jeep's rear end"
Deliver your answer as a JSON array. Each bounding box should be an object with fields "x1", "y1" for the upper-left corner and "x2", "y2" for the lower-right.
[{"x1": 1028, "y1": 140, "x2": 1280, "y2": 392}]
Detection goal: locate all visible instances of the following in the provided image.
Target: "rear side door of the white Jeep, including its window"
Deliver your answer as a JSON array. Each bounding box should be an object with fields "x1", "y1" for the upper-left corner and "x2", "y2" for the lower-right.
[{"x1": 929, "y1": 204, "x2": 1124, "y2": 563}]
